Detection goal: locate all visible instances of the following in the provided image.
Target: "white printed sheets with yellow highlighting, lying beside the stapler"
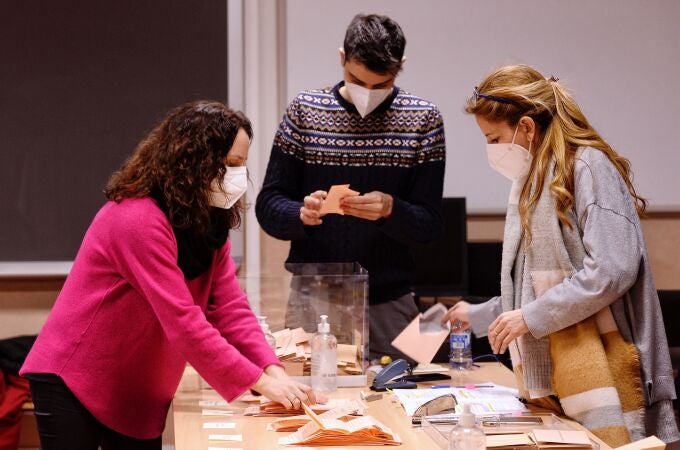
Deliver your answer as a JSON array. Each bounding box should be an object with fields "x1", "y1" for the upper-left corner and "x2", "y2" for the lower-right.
[{"x1": 393, "y1": 382, "x2": 528, "y2": 416}]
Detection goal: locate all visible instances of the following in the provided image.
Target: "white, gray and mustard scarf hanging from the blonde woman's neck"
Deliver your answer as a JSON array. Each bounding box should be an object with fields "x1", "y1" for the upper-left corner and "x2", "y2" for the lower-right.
[{"x1": 501, "y1": 162, "x2": 645, "y2": 447}]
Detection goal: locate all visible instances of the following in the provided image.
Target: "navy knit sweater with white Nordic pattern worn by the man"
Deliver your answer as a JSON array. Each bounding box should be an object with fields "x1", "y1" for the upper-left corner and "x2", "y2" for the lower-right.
[{"x1": 256, "y1": 82, "x2": 446, "y2": 303}]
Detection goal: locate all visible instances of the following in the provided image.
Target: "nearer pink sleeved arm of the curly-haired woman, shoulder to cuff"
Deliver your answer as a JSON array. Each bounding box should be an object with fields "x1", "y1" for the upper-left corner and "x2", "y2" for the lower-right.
[{"x1": 108, "y1": 207, "x2": 262, "y2": 401}]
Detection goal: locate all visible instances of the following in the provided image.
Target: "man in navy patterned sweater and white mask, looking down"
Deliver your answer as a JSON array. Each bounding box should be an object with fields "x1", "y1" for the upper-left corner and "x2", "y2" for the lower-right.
[{"x1": 256, "y1": 15, "x2": 446, "y2": 359}]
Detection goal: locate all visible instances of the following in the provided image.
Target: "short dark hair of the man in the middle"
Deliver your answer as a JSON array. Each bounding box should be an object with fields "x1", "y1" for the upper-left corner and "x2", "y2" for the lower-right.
[{"x1": 344, "y1": 14, "x2": 406, "y2": 76}]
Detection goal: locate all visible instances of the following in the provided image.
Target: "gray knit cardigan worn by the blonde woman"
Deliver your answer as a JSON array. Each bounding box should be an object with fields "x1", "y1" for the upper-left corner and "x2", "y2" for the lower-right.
[{"x1": 470, "y1": 148, "x2": 680, "y2": 442}]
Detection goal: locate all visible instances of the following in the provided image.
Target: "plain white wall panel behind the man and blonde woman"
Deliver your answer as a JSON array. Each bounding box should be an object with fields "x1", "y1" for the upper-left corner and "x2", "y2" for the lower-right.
[{"x1": 285, "y1": 0, "x2": 680, "y2": 212}]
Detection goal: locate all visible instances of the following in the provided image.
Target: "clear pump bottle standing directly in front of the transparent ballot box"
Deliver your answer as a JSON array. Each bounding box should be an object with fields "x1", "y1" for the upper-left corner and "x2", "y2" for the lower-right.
[{"x1": 312, "y1": 315, "x2": 338, "y2": 392}]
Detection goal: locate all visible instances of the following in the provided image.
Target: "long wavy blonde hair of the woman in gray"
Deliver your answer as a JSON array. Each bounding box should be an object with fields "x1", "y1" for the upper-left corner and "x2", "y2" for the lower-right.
[{"x1": 465, "y1": 65, "x2": 647, "y2": 242}]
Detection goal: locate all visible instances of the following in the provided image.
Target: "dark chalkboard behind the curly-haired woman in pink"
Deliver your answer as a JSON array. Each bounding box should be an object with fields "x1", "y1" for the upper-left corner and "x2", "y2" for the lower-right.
[{"x1": 0, "y1": 0, "x2": 227, "y2": 261}]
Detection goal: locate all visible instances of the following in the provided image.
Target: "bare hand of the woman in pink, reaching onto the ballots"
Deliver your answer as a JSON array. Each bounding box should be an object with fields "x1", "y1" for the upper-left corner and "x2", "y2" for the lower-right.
[{"x1": 252, "y1": 365, "x2": 317, "y2": 409}]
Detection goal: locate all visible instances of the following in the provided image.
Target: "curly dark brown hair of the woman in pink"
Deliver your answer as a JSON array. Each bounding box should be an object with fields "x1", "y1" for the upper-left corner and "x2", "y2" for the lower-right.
[{"x1": 104, "y1": 100, "x2": 253, "y2": 233}]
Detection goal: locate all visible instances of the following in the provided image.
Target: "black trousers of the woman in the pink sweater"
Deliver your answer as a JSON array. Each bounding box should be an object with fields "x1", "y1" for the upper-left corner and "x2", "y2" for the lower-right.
[{"x1": 30, "y1": 374, "x2": 162, "y2": 450}]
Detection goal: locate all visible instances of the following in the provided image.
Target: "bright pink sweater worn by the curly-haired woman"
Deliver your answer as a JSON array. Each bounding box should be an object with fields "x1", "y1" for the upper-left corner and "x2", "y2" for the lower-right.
[{"x1": 21, "y1": 198, "x2": 280, "y2": 439}]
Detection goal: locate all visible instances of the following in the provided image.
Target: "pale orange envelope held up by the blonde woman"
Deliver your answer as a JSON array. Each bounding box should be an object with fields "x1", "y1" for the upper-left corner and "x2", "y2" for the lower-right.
[{"x1": 392, "y1": 303, "x2": 451, "y2": 364}]
